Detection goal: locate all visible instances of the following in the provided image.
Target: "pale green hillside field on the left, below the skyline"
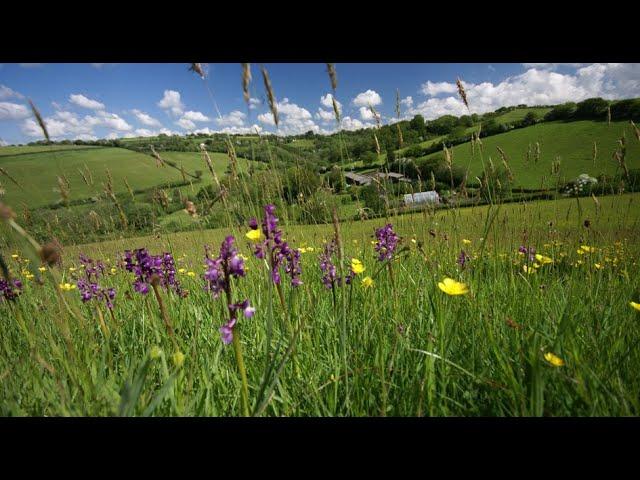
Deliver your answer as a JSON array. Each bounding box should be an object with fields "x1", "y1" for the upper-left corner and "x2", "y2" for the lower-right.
[{"x1": 0, "y1": 147, "x2": 262, "y2": 208}]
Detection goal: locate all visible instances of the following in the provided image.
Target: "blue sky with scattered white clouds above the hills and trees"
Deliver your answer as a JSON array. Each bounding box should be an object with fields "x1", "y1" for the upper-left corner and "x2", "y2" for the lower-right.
[{"x1": 0, "y1": 63, "x2": 640, "y2": 145}]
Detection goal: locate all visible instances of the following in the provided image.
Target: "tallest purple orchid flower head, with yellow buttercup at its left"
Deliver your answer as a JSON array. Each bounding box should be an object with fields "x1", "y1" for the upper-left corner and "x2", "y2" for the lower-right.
[{"x1": 249, "y1": 205, "x2": 302, "y2": 287}]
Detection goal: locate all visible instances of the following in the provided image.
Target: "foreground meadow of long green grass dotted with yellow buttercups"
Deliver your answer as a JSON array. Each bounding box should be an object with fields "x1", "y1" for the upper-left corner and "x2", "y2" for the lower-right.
[{"x1": 0, "y1": 194, "x2": 640, "y2": 416}]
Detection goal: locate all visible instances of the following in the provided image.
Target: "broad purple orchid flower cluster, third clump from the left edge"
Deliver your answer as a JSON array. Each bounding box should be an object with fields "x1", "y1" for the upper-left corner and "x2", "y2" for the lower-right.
[{"x1": 124, "y1": 248, "x2": 186, "y2": 297}]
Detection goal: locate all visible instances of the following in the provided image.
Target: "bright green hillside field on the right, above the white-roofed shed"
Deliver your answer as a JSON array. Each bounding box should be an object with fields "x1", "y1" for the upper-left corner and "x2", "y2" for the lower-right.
[{"x1": 420, "y1": 121, "x2": 640, "y2": 188}]
